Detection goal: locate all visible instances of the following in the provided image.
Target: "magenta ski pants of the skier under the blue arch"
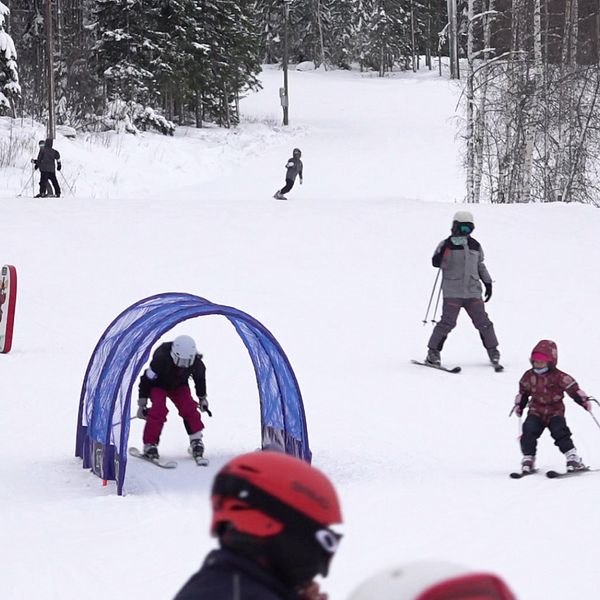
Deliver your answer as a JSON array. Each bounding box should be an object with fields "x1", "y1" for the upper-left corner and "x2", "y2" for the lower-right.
[{"x1": 143, "y1": 385, "x2": 204, "y2": 444}]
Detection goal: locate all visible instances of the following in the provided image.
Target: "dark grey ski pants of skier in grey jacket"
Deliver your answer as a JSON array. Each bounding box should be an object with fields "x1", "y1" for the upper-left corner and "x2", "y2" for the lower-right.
[{"x1": 427, "y1": 298, "x2": 498, "y2": 351}]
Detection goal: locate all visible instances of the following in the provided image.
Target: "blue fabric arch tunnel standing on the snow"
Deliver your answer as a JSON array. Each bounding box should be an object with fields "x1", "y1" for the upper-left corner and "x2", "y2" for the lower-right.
[{"x1": 75, "y1": 293, "x2": 311, "y2": 495}]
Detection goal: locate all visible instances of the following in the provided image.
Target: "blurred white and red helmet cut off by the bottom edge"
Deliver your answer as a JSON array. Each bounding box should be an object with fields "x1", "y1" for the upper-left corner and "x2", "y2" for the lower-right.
[{"x1": 349, "y1": 561, "x2": 516, "y2": 600}]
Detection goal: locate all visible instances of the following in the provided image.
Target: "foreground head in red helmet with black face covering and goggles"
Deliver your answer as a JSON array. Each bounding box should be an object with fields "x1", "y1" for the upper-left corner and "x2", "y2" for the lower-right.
[{"x1": 211, "y1": 451, "x2": 342, "y2": 586}]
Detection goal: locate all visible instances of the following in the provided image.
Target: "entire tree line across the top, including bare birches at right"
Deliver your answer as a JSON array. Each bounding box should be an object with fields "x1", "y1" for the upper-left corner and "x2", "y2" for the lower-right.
[{"x1": 0, "y1": 0, "x2": 600, "y2": 203}]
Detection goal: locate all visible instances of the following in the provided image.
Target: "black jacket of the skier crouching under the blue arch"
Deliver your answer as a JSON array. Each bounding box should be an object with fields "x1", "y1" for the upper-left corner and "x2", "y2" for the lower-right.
[{"x1": 139, "y1": 342, "x2": 206, "y2": 398}]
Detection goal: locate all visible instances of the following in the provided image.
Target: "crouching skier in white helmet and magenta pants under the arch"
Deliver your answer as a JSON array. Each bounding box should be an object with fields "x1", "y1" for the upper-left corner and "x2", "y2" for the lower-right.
[{"x1": 137, "y1": 335, "x2": 210, "y2": 462}]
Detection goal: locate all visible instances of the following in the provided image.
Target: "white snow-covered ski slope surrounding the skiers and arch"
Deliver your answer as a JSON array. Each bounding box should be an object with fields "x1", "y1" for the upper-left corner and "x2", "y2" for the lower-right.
[{"x1": 0, "y1": 63, "x2": 600, "y2": 600}]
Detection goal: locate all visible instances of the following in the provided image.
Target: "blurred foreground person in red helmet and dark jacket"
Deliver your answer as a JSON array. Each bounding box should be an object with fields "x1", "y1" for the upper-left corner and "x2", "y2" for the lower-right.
[{"x1": 175, "y1": 451, "x2": 342, "y2": 600}]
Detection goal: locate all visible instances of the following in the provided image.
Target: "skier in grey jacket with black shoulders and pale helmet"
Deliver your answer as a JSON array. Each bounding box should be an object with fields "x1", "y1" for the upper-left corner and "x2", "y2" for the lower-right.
[{"x1": 425, "y1": 211, "x2": 500, "y2": 366}]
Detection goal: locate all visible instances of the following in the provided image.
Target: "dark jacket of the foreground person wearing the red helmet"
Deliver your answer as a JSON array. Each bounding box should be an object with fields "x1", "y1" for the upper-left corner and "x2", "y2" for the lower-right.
[{"x1": 174, "y1": 549, "x2": 298, "y2": 600}]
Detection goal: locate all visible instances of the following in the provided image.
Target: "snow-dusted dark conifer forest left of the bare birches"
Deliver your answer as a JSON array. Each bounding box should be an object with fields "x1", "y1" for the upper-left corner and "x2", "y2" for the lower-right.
[{"x1": 5, "y1": 0, "x2": 446, "y2": 133}]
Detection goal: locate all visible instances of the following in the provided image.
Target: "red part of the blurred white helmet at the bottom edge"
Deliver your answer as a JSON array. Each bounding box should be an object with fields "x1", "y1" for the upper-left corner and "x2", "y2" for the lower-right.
[{"x1": 415, "y1": 573, "x2": 516, "y2": 600}]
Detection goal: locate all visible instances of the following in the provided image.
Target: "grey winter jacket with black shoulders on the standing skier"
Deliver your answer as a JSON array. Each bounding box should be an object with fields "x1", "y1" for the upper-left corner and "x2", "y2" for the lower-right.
[{"x1": 431, "y1": 236, "x2": 492, "y2": 298}]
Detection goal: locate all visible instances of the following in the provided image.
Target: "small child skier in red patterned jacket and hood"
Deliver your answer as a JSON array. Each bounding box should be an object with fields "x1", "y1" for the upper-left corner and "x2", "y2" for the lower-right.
[{"x1": 515, "y1": 340, "x2": 592, "y2": 473}]
